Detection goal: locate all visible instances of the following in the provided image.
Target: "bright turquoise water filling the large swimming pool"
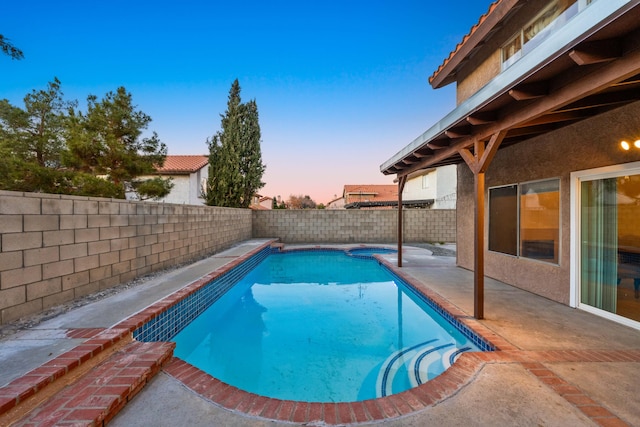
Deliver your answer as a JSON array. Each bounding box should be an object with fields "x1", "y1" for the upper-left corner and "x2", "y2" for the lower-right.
[{"x1": 173, "y1": 251, "x2": 479, "y2": 402}]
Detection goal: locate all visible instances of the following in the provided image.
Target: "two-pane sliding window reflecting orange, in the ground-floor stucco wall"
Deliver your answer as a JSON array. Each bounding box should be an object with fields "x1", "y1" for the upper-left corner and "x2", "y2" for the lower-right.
[{"x1": 489, "y1": 179, "x2": 560, "y2": 264}]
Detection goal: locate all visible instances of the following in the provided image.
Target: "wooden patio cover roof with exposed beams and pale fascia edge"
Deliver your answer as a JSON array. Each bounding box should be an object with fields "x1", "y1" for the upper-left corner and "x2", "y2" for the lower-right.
[{"x1": 380, "y1": 0, "x2": 640, "y2": 176}]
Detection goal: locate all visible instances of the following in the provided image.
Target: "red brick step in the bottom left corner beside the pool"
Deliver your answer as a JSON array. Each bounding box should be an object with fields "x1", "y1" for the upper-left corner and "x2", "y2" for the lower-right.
[{"x1": 10, "y1": 341, "x2": 175, "y2": 426}]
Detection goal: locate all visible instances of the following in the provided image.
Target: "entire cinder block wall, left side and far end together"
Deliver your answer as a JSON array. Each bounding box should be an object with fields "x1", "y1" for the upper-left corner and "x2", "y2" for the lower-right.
[{"x1": 0, "y1": 191, "x2": 456, "y2": 324}]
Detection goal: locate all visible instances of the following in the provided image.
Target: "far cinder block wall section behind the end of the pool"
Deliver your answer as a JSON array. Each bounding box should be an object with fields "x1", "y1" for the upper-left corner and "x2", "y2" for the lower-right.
[{"x1": 253, "y1": 209, "x2": 456, "y2": 243}]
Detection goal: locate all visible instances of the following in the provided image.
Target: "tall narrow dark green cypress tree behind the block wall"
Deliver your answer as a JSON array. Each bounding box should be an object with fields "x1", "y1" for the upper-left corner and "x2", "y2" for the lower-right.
[{"x1": 205, "y1": 79, "x2": 265, "y2": 208}]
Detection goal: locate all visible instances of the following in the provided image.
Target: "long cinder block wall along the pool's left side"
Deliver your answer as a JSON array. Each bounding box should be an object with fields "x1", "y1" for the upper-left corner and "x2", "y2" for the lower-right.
[{"x1": 0, "y1": 191, "x2": 252, "y2": 324}]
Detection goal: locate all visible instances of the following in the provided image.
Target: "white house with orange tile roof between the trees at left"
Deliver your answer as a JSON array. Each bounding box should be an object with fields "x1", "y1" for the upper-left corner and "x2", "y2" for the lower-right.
[{"x1": 141, "y1": 155, "x2": 209, "y2": 205}]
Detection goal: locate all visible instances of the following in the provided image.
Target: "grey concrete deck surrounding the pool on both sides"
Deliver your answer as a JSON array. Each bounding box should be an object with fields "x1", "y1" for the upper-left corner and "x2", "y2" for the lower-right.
[{"x1": 0, "y1": 240, "x2": 640, "y2": 426}]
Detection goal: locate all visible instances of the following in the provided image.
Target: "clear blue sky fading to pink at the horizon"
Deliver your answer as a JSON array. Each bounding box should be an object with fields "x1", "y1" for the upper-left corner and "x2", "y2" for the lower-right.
[{"x1": 0, "y1": 0, "x2": 491, "y2": 203}]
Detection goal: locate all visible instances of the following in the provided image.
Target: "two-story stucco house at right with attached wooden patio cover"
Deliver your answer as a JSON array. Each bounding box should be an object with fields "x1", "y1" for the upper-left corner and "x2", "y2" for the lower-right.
[{"x1": 381, "y1": 0, "x2": 640, "y2": 329}]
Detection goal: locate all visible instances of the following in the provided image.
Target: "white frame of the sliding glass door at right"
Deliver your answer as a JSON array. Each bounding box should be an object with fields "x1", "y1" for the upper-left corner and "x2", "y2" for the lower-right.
[{"x1": 569, "y1": 162, "x2": 640, "y2": 330}]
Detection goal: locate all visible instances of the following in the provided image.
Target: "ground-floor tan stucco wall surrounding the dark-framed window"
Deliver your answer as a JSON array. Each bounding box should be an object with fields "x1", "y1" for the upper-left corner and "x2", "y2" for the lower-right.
[{"x1": 457, "y1": 102, "x2": 640, "y2": 304}]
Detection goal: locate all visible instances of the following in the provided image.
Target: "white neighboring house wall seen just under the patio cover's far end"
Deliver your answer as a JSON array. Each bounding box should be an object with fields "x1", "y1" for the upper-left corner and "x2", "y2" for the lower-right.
[{"x1": 396, "y1": 165, "x2": 457, "y2": 209}]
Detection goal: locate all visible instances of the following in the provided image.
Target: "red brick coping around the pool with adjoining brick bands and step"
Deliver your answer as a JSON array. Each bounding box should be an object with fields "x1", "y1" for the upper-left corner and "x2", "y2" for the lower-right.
[{"x1": 0, "y1": 241, "x2": 640, "y2": 426}]
